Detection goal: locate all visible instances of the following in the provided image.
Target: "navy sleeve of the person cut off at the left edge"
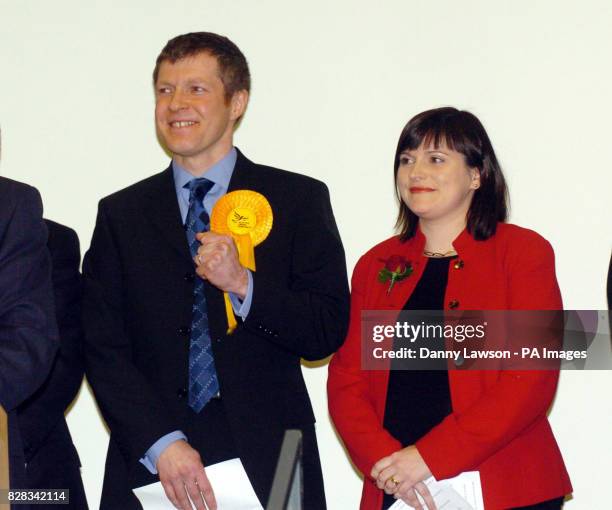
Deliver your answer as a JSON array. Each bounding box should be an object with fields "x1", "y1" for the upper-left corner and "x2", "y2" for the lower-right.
[{"x1": 0, "y1": 186, "x2": 58, "y2": 411}]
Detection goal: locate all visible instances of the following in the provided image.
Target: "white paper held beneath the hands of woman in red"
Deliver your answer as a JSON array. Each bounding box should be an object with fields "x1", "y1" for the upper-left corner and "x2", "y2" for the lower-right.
[{"x1": 389, "y1": 471, "x2": 484, "y2": 510}]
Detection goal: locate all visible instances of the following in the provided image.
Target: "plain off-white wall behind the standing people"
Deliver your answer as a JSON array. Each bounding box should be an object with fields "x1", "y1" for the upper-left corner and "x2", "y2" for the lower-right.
[{"x1": 0, "y1": 0, "x2": 612, "y2": 510}]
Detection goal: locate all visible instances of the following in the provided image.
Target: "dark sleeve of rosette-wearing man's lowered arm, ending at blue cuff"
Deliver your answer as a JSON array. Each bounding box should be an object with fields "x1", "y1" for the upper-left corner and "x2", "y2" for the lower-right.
[{"x1": 83, "y1": 201, "x2": 180, "y2": 469}]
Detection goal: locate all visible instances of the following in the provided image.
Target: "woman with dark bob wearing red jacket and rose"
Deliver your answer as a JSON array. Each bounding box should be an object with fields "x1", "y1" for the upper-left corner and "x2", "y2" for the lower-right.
[{"x1": 328, "y1": 108, "x2": 572, "y2": 510}]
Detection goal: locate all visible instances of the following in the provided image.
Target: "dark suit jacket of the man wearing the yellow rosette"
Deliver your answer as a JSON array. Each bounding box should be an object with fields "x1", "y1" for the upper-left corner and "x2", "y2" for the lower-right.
[{"x1": 83, "y1": 149, "x2": 348, "y2": 508}]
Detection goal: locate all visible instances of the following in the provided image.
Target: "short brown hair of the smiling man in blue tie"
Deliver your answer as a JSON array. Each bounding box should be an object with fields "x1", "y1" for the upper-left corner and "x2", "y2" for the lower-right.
[{"x1": 153, "y1": 32, "x2": 251, "y2": 102}]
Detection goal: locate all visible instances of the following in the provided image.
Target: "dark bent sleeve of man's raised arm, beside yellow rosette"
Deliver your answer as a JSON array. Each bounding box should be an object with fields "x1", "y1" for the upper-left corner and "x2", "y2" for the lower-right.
[{"x1": 245, "y1": 180, "x2": 349, "y2": 360}]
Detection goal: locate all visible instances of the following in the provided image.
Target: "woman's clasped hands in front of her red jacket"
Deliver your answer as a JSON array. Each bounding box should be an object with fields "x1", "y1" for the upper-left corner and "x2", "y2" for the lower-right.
[{"x1": 370, "y1": 445, "x2": 436, "y2": 510}]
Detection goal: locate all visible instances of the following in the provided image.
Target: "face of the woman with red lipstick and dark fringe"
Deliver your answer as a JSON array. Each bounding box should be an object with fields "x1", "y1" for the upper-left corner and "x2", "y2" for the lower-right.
[{"x1": 397, "y1": 145, "x2": 480, "y2": 221}]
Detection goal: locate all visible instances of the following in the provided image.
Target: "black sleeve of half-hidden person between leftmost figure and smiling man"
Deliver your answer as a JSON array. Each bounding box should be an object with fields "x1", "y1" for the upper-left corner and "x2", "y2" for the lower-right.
[{"x1": 19, "y1": 221, "x2": 84, "y2": 458}]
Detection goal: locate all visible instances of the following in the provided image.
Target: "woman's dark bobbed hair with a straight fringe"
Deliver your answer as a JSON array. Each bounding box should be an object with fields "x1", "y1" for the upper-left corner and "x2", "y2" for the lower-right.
[{"x1": 393, "y1": 107, "x2": 509, "y2": 242}]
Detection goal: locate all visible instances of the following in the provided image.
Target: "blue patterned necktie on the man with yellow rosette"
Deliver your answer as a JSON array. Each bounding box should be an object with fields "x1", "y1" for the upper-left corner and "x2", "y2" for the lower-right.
[{"x1": 185, "y1": 178, "x2": 219, "y2": 413}]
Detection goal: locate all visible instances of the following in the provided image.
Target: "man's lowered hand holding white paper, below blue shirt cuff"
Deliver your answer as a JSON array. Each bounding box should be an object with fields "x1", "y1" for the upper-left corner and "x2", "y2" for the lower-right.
[{"x1": 157, "y1": 440, "x2": 217, "y2": 510}]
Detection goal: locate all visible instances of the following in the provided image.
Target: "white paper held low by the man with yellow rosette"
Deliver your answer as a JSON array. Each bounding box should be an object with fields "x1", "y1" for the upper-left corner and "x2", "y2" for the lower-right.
[{"x1": 134, "y1": 458, "x2": 263, "y2": 510}]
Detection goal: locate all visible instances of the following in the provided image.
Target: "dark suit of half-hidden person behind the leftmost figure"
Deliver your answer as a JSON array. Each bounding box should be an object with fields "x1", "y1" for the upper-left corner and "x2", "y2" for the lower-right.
[{"x1": 17, "y1": 220, "x2": 87, "y2": 510}]
